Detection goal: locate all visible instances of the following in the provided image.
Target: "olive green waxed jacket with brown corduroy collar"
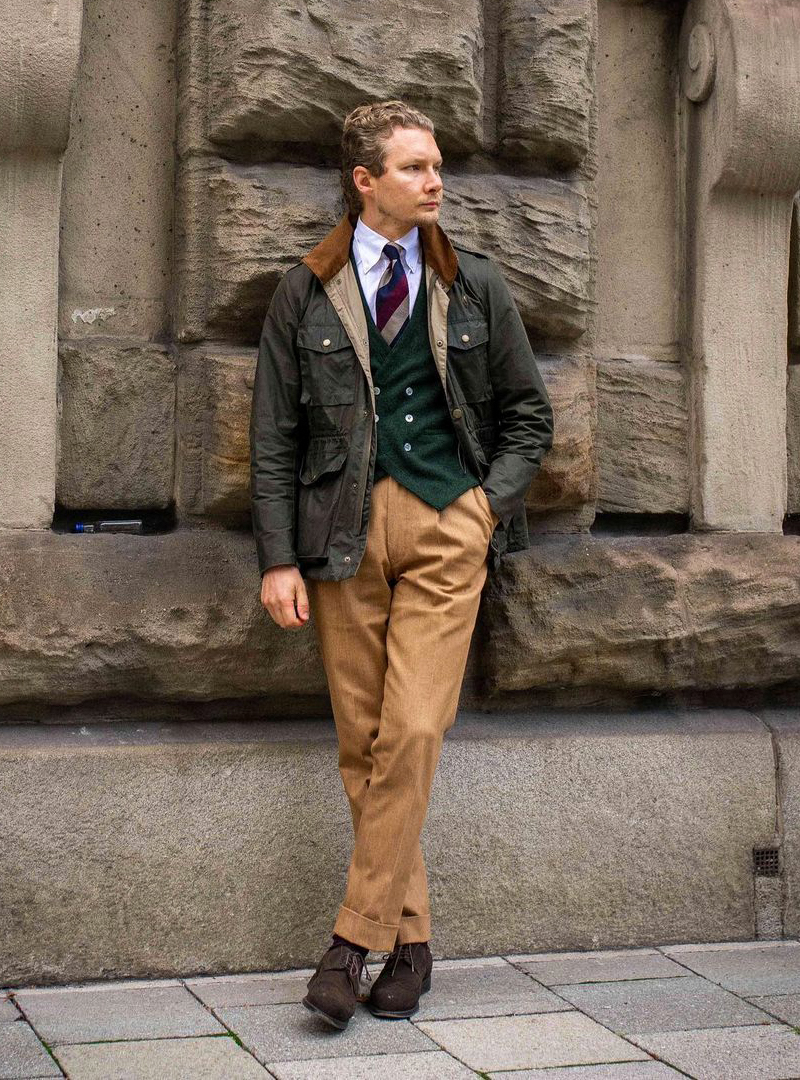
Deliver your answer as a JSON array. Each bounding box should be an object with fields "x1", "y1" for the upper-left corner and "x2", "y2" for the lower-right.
[{"x1": 249, "y1": 214, "x2": 553, "y2": 581}]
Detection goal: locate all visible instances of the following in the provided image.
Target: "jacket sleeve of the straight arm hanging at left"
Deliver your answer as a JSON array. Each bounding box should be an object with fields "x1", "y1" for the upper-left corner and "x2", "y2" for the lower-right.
[{"x1": 249, "y1": 275, "x2": 300, "y2": 575}]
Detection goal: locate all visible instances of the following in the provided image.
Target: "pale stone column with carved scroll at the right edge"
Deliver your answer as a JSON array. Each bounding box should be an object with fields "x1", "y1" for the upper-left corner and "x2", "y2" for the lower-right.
[{"x1": 680, "y1": 0, "x2": 800, "y2": 532}]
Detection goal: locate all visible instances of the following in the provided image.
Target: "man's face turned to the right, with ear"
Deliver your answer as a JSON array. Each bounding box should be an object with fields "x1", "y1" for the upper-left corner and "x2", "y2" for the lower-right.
[{"x1": 353, "y1": 127, "x2": 444, "y2": 240}]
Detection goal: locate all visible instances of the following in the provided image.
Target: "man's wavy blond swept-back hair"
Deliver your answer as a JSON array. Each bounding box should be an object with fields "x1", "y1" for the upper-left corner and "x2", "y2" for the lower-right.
[{"x1": 341, "y1": 100, "x2": 435, "y2": 217}]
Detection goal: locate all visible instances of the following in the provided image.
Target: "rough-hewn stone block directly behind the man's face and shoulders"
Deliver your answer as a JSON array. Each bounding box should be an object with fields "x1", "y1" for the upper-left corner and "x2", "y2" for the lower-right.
[{"x1": 182, "y1": 161, "x2": 592, "y2": 345}]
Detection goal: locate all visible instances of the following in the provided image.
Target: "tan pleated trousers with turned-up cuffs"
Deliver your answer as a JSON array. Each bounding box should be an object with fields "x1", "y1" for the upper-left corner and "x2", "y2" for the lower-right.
[{"x1": 306, "y1": 476, "x2": 497, "y2": 951}]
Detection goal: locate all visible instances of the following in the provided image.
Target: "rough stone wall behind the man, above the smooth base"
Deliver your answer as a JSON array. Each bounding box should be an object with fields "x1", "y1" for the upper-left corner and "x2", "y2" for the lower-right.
[{"x1": 0, "y1": 0, "x2": 800, "y2": 717}]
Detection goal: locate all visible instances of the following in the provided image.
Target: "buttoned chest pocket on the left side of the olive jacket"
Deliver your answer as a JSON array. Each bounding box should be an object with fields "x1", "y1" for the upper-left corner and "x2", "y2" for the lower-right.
[{"x1": 297, "y1": 323, "x2": 360, "y2": 406}]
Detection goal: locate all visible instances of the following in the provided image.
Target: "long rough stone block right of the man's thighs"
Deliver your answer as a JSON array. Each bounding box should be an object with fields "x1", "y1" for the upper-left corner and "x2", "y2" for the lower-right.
[{"x1": 484, "y1": 532, "x2": 800, "y2": 692}]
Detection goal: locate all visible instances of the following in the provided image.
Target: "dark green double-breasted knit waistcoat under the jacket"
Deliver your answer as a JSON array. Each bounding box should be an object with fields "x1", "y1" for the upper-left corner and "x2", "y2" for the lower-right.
[{"x1": 350, "y1": 247, "x2": 480, "y2": 510}]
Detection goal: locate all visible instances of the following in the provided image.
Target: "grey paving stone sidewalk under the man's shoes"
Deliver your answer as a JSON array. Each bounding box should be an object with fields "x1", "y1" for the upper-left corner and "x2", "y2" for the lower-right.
[{"x1": 0, "y1": 940, "x2": 800, "y2": 1080}]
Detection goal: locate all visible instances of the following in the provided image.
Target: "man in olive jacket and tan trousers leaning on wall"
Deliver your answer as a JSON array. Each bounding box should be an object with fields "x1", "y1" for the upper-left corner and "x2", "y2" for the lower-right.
[{"x1": 250, "y1": 100, "x2": 553, "y2": 1028}]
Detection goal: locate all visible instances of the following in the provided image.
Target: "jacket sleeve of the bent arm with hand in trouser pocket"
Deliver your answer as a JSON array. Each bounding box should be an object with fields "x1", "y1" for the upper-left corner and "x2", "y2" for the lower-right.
[{"x1": 483, "y1": 259, "x2": 553, "y2": 528}]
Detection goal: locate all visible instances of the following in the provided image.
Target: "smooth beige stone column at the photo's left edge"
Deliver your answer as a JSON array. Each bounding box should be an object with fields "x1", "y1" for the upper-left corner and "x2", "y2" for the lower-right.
[{"x1": 0, "y1": 0, "x2": 82, "y2": 528}]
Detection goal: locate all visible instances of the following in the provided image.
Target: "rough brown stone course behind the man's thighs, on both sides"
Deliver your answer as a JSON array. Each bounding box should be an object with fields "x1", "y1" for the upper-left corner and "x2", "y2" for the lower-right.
[{"x1": 0, "y1": 527, "x2": 800, "y2": 707}]
